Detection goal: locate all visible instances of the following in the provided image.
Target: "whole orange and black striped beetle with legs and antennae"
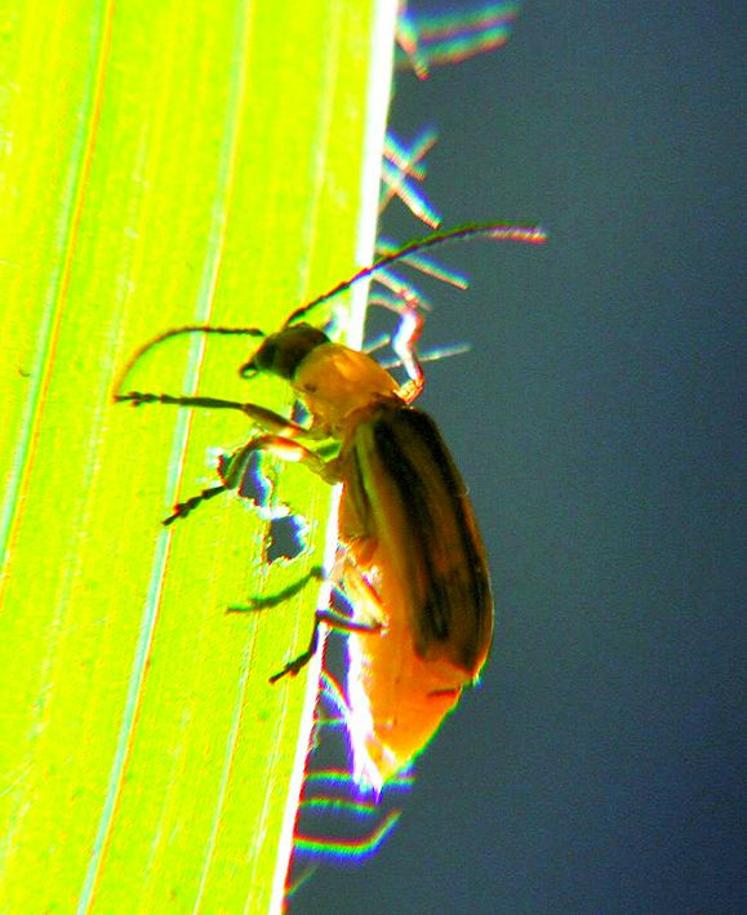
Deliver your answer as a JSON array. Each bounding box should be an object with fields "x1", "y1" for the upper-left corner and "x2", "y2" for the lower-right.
[{"x1": 115, "y1": 224, "x2": 545, "y2": 789}]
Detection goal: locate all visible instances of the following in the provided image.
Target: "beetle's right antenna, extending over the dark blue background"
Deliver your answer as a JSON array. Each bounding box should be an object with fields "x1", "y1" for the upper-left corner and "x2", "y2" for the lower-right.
[{"x1": 284, "y1": 222, "x2": 547, "y2": 327}]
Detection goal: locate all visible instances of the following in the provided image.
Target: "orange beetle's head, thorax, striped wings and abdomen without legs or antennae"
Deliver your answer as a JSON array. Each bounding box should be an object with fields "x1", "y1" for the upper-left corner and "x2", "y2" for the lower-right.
[{"x1": 238, "y1": 324, "x2": 493, "y2": 787}]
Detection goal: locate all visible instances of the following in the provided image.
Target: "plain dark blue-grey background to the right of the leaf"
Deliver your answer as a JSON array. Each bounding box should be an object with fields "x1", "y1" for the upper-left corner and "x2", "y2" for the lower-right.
[{"x1": 293, "y1": 0, "x2": 747, "y2": 915}]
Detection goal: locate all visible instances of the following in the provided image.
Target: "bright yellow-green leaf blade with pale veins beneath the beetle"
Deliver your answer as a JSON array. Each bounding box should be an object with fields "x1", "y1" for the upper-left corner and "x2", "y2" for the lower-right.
[{"x1": 0, "y1": 0, "x2": 396, "y2": 912}]
